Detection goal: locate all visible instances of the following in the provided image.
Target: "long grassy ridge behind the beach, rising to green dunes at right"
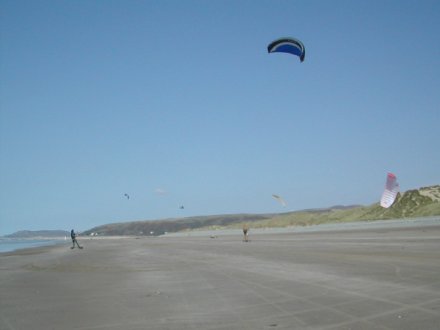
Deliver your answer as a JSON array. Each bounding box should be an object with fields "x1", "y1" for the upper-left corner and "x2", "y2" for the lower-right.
[{"x1": 83, "y1": 185, "x2": 440, "y2": 236}]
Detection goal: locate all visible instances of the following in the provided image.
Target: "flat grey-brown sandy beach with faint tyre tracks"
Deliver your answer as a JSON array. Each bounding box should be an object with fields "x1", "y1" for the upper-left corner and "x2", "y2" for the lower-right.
[{"x1": 0, "y1": 221, "x2": 440, "y2": 330}]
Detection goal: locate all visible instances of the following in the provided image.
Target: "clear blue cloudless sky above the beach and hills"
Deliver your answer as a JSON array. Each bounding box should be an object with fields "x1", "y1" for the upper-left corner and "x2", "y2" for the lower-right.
[{"x1": 0, "y1": 0, "x2": 440, "y2": 235}]
